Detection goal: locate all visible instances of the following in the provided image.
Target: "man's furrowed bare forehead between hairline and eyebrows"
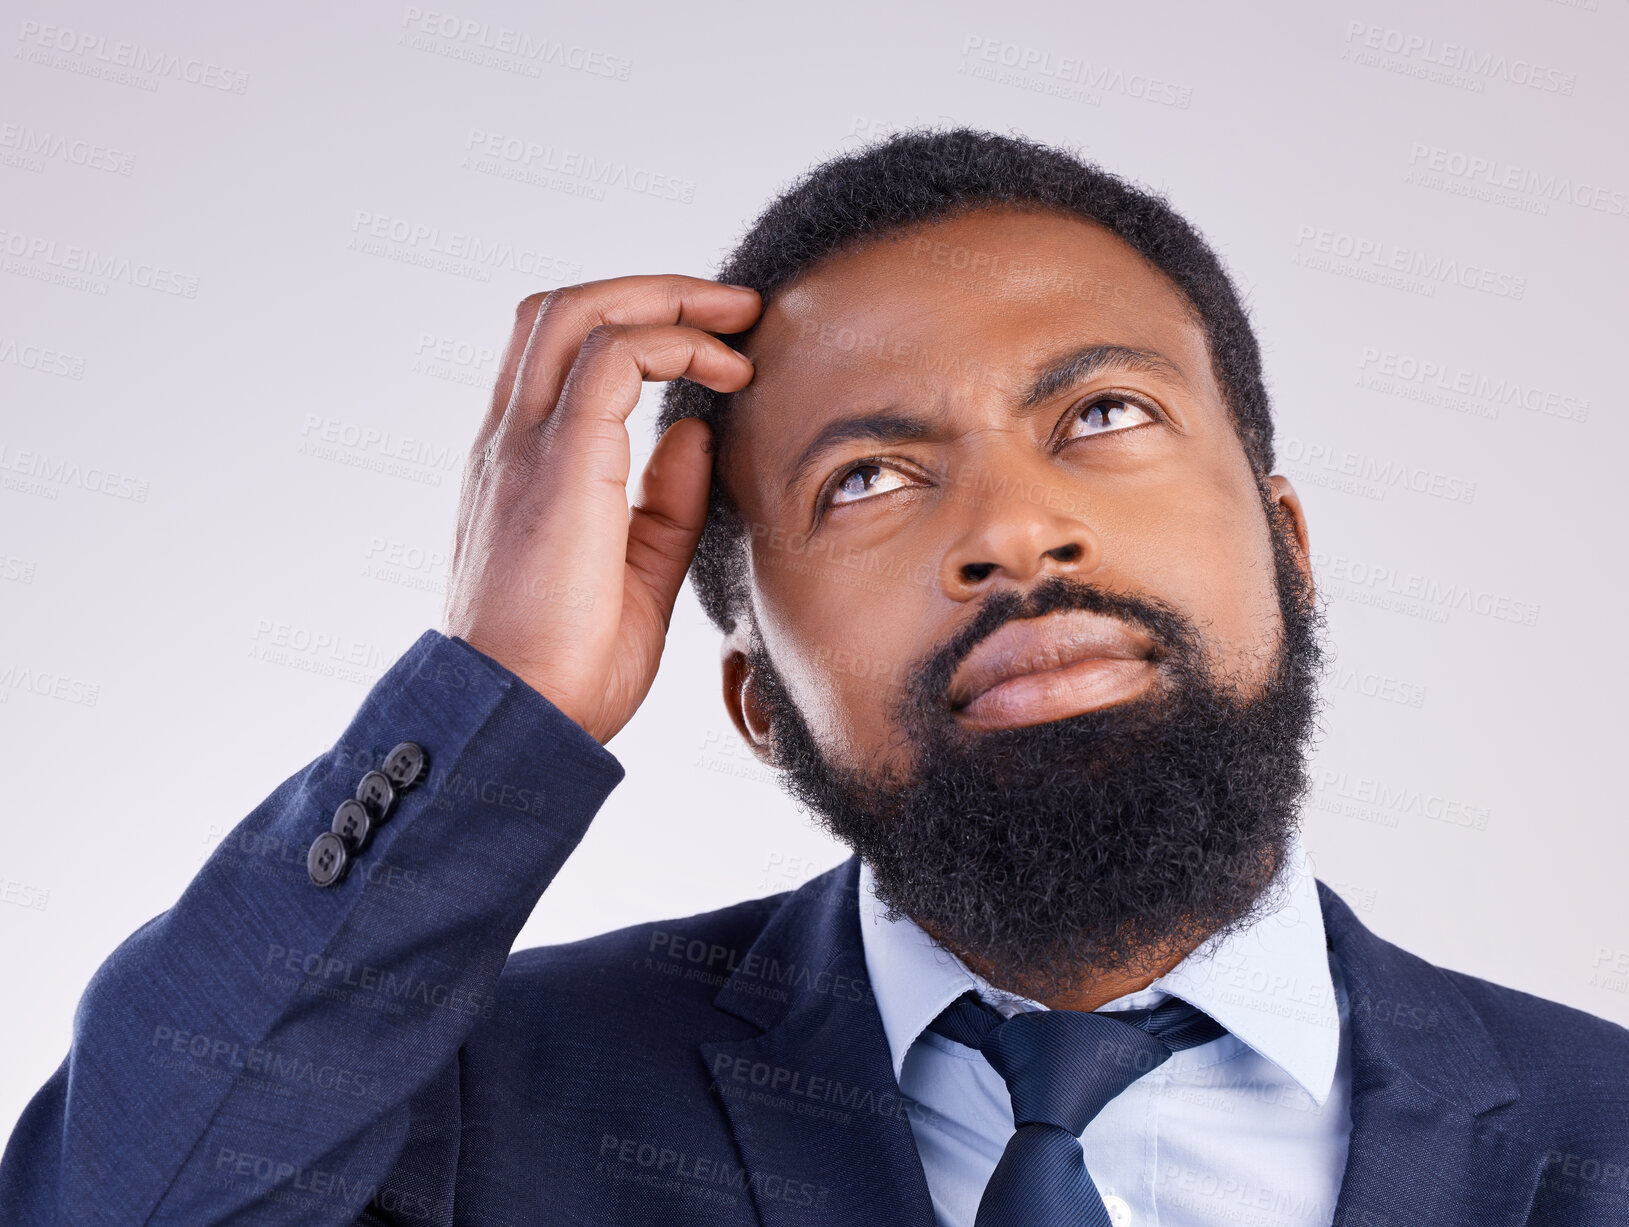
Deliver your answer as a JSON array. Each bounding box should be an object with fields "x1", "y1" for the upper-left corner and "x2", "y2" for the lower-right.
[{"x1": 730, "y1": 207, "x2": 1220, "y2": 494}]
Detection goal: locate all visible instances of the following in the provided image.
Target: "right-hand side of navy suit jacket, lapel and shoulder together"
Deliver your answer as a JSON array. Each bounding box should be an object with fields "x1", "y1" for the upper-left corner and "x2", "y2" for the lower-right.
[{"x1": 1318, "y1": 882, "x2": 1629, "y2": 1227}]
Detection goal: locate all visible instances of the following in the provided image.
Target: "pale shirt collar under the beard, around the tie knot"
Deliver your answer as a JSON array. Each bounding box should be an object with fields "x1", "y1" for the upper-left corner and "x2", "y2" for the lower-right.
[{"x1": 858, "y1": 836, "x2": 1341, "y2": 1105}]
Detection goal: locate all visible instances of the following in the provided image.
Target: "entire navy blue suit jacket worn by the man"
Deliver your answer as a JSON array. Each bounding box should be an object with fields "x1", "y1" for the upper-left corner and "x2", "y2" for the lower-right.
[{"x1": 0, "y1": 631, "x2": 1629, "y2": 1227}]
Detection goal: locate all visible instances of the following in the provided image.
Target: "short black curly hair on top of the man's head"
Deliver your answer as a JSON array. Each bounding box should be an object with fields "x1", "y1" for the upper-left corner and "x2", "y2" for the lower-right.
[{"x1": 656, "y1": 127, "x2": 1274, "y2": 634}]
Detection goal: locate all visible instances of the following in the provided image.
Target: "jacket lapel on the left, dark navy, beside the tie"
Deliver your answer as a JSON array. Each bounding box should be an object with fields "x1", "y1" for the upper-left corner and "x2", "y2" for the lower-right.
[{"x1": 700, "y1": 857, "x2": 933, "y2": 1227}]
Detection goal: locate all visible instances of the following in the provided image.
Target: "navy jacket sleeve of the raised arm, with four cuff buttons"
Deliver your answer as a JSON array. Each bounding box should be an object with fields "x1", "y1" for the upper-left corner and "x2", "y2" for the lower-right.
[{"x1": 0, "y1": 631, "x2": 624, "y2": 1227}]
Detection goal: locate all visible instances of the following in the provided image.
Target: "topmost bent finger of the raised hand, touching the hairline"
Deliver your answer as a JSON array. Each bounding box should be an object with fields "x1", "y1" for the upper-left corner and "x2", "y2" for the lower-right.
[{"x1": 502, "y1": 274, "x2": 761, "y2": 425}]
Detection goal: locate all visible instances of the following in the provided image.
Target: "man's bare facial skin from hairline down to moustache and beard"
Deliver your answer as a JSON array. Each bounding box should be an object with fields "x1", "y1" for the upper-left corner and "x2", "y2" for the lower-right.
[{"x1": 718, "y1": 210, "x2": 1305, "y2": 769}]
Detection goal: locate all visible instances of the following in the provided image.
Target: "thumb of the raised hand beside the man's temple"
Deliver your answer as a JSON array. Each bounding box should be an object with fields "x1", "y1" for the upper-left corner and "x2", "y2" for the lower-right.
[{"x1": 627, "y1": 417, "x2": 712, "y2": 627}]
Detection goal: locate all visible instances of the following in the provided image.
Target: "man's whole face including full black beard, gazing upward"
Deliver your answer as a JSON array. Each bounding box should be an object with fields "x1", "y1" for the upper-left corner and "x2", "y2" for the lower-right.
[{"x1": 717, "y1": 210, "x2": 1311, "y2": 997}]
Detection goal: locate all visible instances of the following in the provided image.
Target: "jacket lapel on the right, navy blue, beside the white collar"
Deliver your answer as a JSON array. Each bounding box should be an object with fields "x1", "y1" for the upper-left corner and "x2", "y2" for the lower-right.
[{"x1": 1318, "y1": 882, "x2": 1544, "y2": 1227}]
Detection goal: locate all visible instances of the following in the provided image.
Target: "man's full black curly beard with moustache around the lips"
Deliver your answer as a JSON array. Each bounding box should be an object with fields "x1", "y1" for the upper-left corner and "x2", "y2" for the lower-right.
[{"x1": 748, "y1": 487, "x2": 1323, "y2": 1001}]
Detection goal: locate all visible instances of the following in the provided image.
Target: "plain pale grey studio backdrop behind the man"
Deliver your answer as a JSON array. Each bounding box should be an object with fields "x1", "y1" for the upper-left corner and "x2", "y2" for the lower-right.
[{"x1": 0, "y1": 0, "x2": 1629, "y2": 1129}]
